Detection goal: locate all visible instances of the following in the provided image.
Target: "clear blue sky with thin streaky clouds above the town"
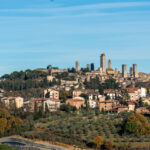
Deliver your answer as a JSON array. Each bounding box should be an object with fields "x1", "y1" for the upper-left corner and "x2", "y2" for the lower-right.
[{"x1": 0, "y1": 0, "x2": 150, "y2": 75}]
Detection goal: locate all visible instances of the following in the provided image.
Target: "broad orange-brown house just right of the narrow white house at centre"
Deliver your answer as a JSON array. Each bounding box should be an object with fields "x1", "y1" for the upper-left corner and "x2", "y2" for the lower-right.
[{"x1": 98, "y1": 100, "x2": 119, "y2": 111}]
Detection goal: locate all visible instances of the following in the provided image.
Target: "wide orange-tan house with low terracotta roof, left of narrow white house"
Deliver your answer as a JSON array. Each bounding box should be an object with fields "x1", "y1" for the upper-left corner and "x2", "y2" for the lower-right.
[{"x1": 66, "y1": 97, "x2": 85, "y2": 109}]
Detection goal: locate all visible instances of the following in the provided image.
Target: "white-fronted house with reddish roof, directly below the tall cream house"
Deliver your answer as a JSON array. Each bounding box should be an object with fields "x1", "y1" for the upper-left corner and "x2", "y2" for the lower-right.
[{"x1": 43, "y1": 99, "x2": 60, "y2": 112}]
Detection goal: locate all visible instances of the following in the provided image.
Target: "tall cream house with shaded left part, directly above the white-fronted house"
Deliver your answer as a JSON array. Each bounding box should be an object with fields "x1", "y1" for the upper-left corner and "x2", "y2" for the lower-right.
[{"x1": 44, "y1": 89, "x2": 59, "y2": 99}]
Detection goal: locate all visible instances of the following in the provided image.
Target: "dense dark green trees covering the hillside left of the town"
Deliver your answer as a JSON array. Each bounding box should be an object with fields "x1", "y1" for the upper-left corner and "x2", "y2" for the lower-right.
[{"x1": 0, "y1": 70, "x2": 60, "y2": 92}]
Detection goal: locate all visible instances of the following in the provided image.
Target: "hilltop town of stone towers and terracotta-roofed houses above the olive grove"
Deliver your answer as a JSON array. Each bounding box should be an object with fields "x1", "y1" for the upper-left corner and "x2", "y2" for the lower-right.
[{"x1": 0, "y1": 54, "x2": 150, "y2": 113}]
